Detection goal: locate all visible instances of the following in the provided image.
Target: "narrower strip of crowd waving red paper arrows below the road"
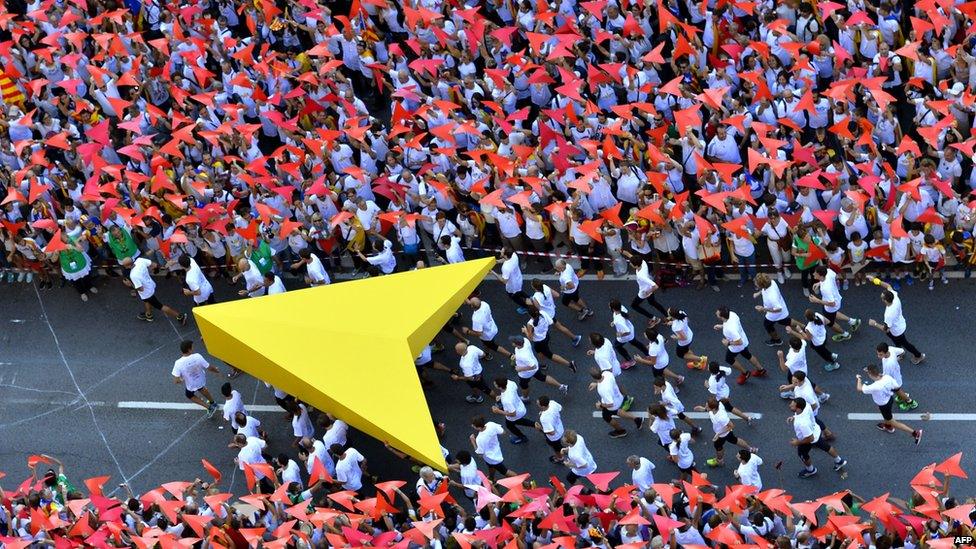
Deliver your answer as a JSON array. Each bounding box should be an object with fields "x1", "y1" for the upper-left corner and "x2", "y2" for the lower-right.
[{"x1": 0, "y1": 454, "x2": 976, "y2": 549}]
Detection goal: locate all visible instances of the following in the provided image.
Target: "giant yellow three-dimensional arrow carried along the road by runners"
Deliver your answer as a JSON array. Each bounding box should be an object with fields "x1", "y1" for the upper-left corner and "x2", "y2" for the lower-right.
[{"x1": 193, "y1": 258, "x2": 494, "y2": 472}]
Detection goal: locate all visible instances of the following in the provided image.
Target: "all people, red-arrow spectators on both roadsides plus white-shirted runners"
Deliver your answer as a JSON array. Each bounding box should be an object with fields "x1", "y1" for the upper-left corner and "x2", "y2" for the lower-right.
[{"x1": 0, "y1": 0, "x2": 976, "y2": 547}]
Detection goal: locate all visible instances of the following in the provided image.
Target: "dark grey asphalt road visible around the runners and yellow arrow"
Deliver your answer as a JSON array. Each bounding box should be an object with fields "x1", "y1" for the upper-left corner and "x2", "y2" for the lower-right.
[{"x1": 0, "y1": 270, "x2": 976, "y2": 498}]
